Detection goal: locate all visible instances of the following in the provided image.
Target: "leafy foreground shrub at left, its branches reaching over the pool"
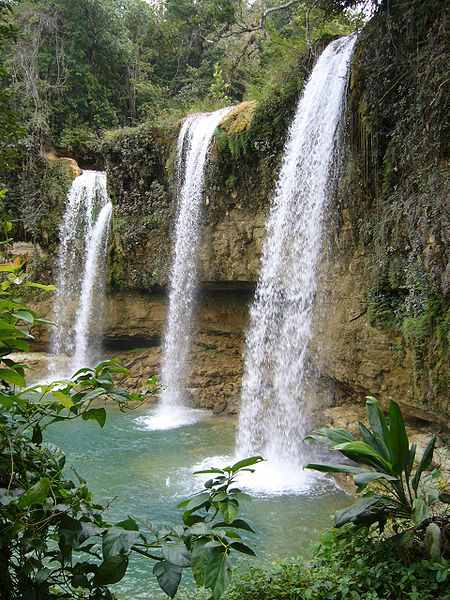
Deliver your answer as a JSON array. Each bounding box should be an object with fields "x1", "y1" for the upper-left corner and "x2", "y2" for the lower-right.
[{"x1": 0, "y1": 222, "x2": 262, "y2": 600}]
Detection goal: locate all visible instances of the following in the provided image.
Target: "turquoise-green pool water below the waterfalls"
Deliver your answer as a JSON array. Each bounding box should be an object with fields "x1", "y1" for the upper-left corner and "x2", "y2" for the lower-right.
[{"x1": 48, "y1": 407, "x2": 351, "y2": 600}]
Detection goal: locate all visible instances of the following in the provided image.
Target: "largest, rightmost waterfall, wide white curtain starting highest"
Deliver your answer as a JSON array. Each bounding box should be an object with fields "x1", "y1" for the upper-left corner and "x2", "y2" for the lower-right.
[{"x1": 237, "y1": 35, "x2": 356, "y2": 478}]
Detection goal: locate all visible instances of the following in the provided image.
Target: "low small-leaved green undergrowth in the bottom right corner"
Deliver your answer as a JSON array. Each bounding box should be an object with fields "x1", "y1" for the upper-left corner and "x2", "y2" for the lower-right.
[{"x1": 182, "y1": 527, "x2": 450, "y2": 600}]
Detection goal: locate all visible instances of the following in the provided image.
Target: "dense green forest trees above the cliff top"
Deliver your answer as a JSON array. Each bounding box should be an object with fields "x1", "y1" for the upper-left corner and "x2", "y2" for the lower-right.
[{"x1": 0, "y1": 0, "x2": 366, "y2": 161}]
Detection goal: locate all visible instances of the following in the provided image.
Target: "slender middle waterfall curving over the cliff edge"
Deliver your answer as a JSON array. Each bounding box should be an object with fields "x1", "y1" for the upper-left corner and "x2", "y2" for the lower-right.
[{"x1": 154, "y1": 108, "x2": 230, "y2": 427}]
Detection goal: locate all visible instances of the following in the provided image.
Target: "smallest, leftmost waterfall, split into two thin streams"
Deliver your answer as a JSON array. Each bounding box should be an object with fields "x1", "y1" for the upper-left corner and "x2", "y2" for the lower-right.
[{"x1": 51, "y1": 171, "x2": 112, "y2": 376}]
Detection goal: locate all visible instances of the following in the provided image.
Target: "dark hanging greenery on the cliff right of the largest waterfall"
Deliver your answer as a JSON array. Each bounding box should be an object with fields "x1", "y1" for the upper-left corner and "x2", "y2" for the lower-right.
[{"x1": 342, "y1": 0, "x2": 449, "y2": 415}]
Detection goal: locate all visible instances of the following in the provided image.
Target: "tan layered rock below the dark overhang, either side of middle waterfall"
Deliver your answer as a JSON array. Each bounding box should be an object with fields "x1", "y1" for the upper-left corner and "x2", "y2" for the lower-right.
[{"x1": 105, "y1": 290, "x2": 251, "y2": 414}]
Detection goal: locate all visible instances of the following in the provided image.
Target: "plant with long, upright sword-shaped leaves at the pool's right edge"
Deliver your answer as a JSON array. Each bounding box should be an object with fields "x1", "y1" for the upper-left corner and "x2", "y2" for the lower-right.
[{"x1": 306, "y1": 397, "x2": 439, "y2": 529}]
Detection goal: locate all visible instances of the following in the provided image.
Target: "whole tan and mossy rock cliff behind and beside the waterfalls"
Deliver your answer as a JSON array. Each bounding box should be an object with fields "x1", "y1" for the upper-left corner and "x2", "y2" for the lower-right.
[{"x1": 30, "y1": 2, "x2": 450, "y2": 426}]
